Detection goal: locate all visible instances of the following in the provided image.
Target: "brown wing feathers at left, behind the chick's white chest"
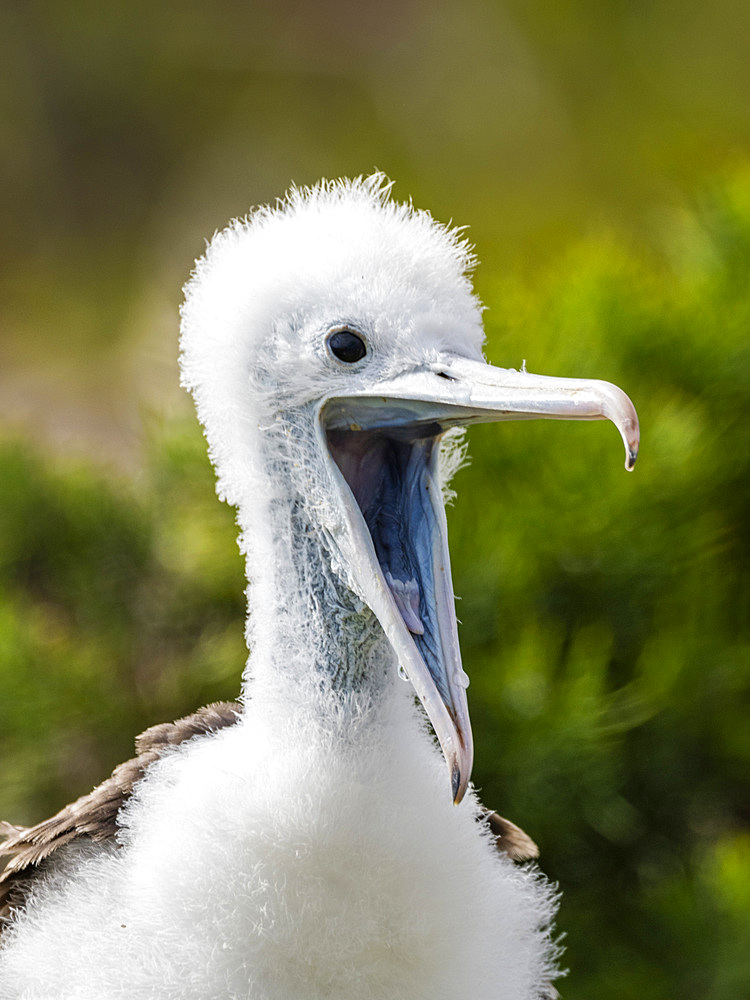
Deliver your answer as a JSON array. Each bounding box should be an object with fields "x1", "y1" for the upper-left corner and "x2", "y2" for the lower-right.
[{"x1": 0, "y1": 702, "x2": 241, "y2": 920}]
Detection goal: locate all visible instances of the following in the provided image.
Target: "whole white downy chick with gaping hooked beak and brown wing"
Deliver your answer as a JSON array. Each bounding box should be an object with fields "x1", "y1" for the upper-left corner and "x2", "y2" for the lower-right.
[{"x1": 0, "y1": 174, "x2": 638, "y2": 1000}]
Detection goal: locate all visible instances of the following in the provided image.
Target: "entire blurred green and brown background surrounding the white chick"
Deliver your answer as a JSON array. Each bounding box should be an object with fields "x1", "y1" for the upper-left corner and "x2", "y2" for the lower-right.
[{"x1": 0, "y1": 0, "x2": 750, "y2": 1000}]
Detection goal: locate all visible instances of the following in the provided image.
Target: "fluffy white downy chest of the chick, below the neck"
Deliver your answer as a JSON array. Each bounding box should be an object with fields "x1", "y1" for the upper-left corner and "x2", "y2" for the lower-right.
[{"x1": 0, "y1": 698, "x2": 550, "y2": 1000}]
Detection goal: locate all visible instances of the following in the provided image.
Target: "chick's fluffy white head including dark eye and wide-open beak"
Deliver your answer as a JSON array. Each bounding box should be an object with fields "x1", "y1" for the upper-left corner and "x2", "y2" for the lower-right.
[{"x1": 181, "y1": 174, "x2": 638, "y2": 802}]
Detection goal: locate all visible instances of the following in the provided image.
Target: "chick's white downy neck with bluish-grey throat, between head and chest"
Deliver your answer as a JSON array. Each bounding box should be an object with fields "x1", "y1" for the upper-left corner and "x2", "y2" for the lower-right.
[{"x1": 240, "y1": 404, "x2": 396, "y2": 713}]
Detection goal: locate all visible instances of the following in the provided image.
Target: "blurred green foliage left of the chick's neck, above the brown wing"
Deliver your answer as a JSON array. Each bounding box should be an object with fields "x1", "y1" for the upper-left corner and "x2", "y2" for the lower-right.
[{"x1": 0, "y1": 425, "x2": 245, "y2": 822}]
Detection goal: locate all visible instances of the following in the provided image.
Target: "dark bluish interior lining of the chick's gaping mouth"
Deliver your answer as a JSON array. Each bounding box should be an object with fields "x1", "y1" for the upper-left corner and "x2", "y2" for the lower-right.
[{"x1": 326, "y1": 423, "x2": 448, "y2": 696}]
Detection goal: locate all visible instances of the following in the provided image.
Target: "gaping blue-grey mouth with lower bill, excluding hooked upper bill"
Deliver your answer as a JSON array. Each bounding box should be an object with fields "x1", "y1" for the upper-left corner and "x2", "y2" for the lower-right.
[{"x1": 321, "y1": 396, "x2": 473, "y2": 802}]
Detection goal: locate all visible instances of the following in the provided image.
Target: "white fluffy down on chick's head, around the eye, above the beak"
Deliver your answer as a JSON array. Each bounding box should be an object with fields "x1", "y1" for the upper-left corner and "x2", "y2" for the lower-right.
[{"x1": 181, "y1": 173, "x2": 484, "y2": 503}]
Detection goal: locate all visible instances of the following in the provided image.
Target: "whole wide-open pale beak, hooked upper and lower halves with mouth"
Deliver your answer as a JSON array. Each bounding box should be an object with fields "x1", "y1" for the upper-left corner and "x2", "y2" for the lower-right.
[{"x1": 320, "y1": 355, "x2": 638, "y2": 803}]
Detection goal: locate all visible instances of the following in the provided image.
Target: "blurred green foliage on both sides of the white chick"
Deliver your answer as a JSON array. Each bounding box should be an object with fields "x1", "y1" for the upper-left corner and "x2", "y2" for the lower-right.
[{"x1": 0, "y1": 169, "x2": 750, "y2": 1000}]
